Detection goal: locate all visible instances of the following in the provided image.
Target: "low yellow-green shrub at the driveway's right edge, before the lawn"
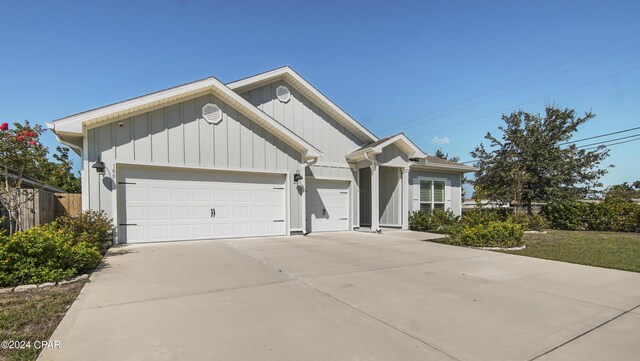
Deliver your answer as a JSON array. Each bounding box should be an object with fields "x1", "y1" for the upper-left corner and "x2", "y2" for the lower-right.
[{"x1": 454, "y1": 221, "x2": 524, "y2": 247}]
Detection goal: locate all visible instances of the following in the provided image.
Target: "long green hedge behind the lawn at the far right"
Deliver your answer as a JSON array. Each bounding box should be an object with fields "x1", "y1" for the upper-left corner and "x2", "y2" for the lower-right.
[{"x1": 541, "y1": 200, "x2": 640, "y2": 232}]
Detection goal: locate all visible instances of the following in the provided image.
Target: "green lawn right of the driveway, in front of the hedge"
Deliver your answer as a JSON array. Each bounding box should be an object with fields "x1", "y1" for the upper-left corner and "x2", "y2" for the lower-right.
[{"x1": 503, "y1": 230, "x2": 640, "y2": 272}]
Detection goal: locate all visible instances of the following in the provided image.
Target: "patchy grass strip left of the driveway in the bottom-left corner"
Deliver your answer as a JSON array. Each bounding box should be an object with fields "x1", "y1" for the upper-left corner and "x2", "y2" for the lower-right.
[{"x1": 0, "y1": 281, "x2": 85, "y2": 360}]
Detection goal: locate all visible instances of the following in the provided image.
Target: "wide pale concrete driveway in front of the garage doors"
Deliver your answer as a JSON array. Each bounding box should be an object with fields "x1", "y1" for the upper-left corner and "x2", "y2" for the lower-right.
[{"x1": 40, "y1": 231, "x2": 640, "y2": 361}]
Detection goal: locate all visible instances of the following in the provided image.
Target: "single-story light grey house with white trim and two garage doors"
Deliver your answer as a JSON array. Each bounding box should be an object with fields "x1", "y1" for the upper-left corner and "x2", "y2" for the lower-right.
[{"x1": 47, "y1": 66, "x2": 476, "y2": 243}]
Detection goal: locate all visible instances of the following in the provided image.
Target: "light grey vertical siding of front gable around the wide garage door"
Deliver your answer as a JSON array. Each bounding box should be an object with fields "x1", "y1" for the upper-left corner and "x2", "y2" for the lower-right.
[{"x1": 83, "y1": 95, "x2": 302, "y2": 229}]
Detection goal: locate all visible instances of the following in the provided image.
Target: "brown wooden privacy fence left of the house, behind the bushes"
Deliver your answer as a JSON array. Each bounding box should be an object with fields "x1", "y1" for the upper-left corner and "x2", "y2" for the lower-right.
[{"x1": 2, "y1": 189, "x2": 82, "y2": 230}]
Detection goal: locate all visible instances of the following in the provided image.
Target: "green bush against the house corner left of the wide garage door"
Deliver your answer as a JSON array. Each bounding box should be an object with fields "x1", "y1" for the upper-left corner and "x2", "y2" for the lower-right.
[{"x1": 52, "y1": 210, "x2": 113, "y2": 253}]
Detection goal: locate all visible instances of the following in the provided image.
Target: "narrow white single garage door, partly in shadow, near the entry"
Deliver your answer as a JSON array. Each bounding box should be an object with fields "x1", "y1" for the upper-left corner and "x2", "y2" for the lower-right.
[{"x1": 306, "y1": 179, "x2": 349, "y2": 232}]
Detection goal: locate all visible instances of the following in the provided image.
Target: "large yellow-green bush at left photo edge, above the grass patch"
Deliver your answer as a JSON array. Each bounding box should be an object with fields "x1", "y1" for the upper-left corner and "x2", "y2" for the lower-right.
[{"x1": 0, "y1": 225, "x2": 102, "y2": 286}]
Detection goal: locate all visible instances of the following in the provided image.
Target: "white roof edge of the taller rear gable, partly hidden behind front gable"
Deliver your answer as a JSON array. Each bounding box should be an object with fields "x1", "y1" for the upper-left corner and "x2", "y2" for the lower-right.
[{"x1": 227, "y1": 66, "x2": 378, "y2": 142}]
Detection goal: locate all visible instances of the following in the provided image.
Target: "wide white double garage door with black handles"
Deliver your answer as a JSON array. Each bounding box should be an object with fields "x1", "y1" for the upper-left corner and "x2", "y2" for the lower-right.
[{"x1": 118, "y1": 167, "x2": 286, "y2": 243}]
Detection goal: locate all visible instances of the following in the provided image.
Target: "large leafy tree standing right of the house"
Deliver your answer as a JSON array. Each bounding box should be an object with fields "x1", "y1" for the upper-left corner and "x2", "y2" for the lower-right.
[{"x1": 471, "y1": 105, "x2": 609, "y2": 213}]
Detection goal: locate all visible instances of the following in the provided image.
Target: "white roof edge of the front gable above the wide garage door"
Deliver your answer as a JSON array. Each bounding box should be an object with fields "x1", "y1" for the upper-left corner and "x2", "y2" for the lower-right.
[{"x1": 47, "y1": 77, "x2": 322, "y2": 158}]
